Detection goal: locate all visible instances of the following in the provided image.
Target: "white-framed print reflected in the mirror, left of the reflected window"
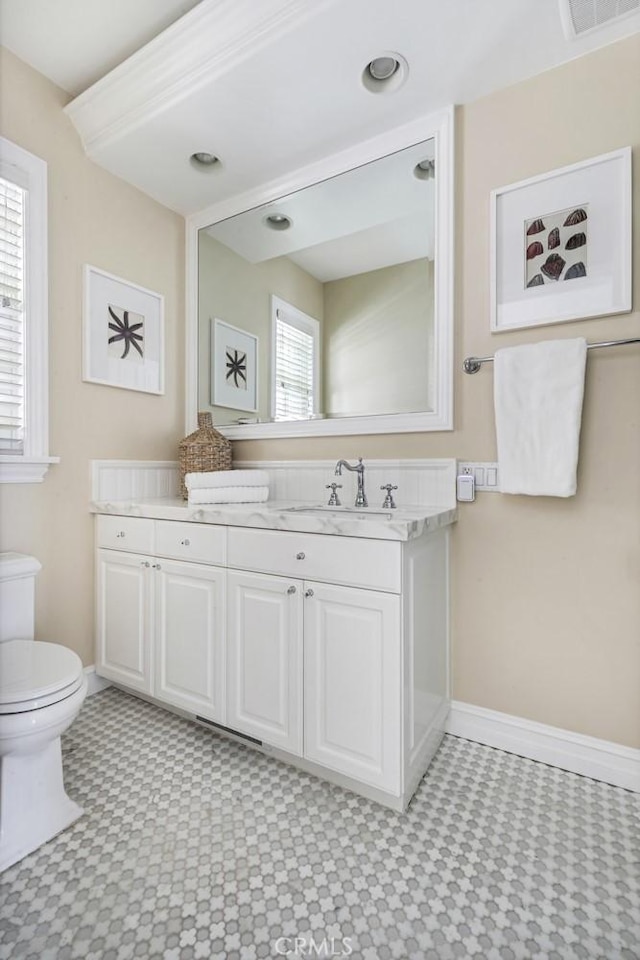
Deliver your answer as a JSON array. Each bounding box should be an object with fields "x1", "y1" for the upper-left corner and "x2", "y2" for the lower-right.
[{"x1": 211, "y1": 318, "x2": 258, "y2": 413}]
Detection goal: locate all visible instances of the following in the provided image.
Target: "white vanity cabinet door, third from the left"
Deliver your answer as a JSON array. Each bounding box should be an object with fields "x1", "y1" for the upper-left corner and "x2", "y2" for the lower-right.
[{"x1": 227, "y1": 571, "x2": 302, "y2": 756}]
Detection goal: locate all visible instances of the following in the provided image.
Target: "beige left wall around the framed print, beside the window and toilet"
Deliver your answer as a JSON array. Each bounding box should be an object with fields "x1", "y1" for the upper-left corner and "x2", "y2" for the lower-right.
[{"x1": 0, "y1": 50, "x2": 184, "y2": 664}]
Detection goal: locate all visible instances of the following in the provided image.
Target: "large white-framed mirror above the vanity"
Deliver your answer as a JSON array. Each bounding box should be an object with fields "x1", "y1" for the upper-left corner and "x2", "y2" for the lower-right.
[{"x1": 187, "y1": 108, "x2": 454, "y2": 439}]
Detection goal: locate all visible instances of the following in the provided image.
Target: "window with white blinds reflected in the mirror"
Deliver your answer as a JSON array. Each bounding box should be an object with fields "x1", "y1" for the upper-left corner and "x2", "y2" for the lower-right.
[{"x1": 271, "y1": 297, "x2": 320, "y2": 420}]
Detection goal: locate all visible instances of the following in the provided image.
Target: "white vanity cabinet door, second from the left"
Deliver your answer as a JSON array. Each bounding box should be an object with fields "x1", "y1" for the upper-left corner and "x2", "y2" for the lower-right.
[{"x1": 152, "y1": 560, "x2": 226, "y2": 723}]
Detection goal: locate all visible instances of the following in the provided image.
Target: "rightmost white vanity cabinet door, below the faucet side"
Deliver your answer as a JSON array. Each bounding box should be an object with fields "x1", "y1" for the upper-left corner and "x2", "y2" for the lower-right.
[{"x1": 304, "y1": 583, "x2": 401, "y2": 794}]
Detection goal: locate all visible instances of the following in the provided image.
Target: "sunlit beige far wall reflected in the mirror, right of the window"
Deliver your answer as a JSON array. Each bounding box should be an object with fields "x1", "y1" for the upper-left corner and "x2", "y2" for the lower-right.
[{"x1": 323, "y1": 259, "x2": 433, "y2": 416}]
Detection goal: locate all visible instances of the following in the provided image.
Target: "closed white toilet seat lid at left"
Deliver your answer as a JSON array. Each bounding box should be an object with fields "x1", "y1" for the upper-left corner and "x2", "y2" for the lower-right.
[{"x1": 0, "y1": 640, "x2": 84, "y2": 715}]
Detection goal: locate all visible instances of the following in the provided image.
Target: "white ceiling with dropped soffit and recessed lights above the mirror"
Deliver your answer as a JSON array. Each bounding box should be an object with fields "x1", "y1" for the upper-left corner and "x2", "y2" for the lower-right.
[{"x1": 0, "y1": 0, "x2": 640, "y2": 214}]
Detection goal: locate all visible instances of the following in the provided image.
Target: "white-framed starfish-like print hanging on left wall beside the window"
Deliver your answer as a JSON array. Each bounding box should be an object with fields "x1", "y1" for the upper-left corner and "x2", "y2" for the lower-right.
[{"x1": 82, "y1": 264, "x2": 164, "y2": 394}]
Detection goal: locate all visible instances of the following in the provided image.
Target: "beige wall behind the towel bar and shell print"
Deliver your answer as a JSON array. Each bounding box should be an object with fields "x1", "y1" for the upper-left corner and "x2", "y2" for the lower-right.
[{"x1": 234, "y1": 35, "x2": 640, "y2": 747}]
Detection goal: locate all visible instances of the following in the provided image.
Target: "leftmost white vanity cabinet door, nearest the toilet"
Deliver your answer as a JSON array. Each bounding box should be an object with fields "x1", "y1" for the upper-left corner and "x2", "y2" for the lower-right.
[{"x1": 96, "y1": 550, "x2": 154, "y2": 693}]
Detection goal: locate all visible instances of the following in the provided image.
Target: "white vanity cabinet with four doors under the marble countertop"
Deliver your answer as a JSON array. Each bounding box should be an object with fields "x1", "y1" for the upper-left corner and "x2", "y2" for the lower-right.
[{"x1": 96, "y1": 515, "x2": 449, "y2": 810}]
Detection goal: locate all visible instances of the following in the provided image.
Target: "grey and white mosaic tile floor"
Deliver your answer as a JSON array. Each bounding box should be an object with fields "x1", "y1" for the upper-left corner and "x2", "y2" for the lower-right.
[{"x1": 0, "y1": 688, "x2": 640, "y2": 960}]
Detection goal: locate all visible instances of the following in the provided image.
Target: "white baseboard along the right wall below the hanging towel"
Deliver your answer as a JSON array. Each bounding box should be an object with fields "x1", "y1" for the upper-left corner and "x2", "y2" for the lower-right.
[{"x1": 447, "y1": 700, "x2": 640, "y2": 793}]
